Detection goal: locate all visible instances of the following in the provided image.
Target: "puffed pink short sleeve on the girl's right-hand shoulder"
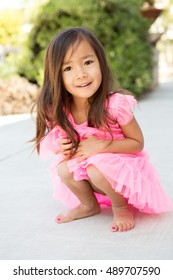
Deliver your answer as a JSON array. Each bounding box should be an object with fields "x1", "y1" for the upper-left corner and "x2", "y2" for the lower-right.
[{"x1": 109, "y1": 93, "x2": 137, "y2": 125}]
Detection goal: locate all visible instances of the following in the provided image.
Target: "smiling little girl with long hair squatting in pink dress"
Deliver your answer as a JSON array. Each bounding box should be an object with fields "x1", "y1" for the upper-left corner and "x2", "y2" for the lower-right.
[{"x1": 35, "y1": 27, "x2": 173, "y2": 231}]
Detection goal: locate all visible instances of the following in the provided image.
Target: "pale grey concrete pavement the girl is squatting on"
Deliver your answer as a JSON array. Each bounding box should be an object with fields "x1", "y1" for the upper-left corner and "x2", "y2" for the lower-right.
[{"x1": 0, "y1": 82, "x2": 173, "y2": 260}]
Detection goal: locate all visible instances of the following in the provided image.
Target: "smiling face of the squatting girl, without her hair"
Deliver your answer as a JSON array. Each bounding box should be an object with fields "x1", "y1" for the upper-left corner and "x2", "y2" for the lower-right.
[{"x1": 62, "y1": 40, "x2": 102, "y2": 102}]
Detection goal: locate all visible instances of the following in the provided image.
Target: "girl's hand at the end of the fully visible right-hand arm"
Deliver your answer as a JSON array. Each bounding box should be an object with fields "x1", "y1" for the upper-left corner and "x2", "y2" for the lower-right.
[{"x1": 74, "y1": 136, "x2": 107, "y2": 162}]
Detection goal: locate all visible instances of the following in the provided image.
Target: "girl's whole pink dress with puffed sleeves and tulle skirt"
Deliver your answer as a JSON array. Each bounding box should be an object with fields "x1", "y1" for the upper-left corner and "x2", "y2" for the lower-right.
[{"x1": 40, "y1": 93, "x2": 173, "y2": 213}]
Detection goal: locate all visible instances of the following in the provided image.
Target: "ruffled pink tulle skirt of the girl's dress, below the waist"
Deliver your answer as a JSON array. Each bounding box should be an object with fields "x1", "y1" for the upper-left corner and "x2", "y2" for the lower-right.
[{"x1": 50, "y1": 151, "x2": 173, "y2": 214}]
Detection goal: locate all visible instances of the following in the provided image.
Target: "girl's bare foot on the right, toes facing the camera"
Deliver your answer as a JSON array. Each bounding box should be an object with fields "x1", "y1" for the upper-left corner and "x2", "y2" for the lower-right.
[{"x1": 112, "y1": 205, "x2": 135, "y2": 231}]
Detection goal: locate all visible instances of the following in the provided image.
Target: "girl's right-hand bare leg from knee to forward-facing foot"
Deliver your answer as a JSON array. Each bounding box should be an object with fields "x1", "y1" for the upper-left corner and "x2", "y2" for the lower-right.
[{"x1": 87, "y1": 165, "x2": 135, "y2": 231}]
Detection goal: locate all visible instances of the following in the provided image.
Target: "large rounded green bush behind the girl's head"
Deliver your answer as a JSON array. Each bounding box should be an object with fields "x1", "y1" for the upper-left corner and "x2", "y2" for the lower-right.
[{"x1": 19, "y1": 0, "x2": 152, "y2": 98}]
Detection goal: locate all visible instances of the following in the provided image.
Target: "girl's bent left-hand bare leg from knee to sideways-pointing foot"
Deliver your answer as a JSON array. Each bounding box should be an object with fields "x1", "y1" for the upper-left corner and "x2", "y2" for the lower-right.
[{"x1": 56, "y1": 161, "x2": 100, "y2": 223}]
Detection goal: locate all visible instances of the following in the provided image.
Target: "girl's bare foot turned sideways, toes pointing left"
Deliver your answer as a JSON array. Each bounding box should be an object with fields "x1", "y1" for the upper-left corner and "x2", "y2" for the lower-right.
[{"x1": 55, "y1": 204, "x2": 100, "y2": 223}]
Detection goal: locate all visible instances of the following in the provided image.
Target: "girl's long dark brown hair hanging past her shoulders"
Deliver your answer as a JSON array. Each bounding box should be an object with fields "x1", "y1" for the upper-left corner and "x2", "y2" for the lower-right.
[{"x1": 34, "y1": 27, "x2": 113, "y2": 153}]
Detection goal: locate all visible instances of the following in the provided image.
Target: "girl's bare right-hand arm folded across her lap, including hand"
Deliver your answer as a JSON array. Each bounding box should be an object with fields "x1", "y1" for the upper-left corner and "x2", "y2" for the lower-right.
[{"x1": 75, "y1": 117, "x2": 144, "y2": 161}]
